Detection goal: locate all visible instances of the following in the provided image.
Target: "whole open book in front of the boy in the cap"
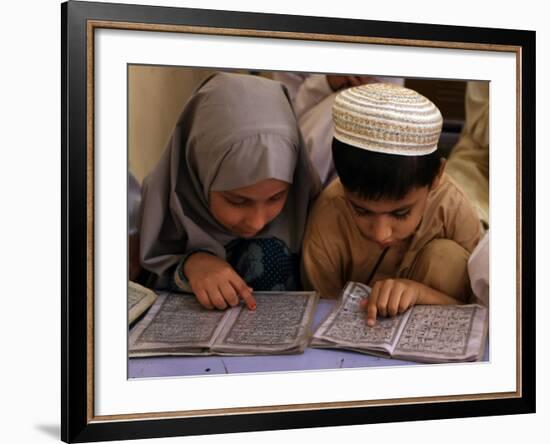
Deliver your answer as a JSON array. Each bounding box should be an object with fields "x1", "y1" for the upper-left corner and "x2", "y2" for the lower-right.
[{"x1": 311, "y1": 282, "x2": 487, "y2": 362}]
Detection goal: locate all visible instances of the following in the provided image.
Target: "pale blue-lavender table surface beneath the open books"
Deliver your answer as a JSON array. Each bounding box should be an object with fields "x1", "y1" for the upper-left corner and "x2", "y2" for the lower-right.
[{"x1": 128, "y1": 299, "x2": 489, "y2": 378}]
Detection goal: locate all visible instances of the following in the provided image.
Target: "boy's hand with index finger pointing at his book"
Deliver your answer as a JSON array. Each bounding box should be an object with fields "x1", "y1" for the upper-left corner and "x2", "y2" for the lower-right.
[{"x1": 361, "y1": 279, "x2": 423, "y2": 327}]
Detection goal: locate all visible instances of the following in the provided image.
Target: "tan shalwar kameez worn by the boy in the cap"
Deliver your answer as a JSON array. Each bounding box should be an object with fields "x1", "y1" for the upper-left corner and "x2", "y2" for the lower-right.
[{"x1": 302, "y1": 174, "x2": 481, "y2": 301}]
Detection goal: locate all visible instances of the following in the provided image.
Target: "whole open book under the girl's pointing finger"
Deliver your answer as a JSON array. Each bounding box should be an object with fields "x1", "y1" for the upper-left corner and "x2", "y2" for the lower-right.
[{"x1": 129, "y1": 291, "x2": 318, "y2": 358}]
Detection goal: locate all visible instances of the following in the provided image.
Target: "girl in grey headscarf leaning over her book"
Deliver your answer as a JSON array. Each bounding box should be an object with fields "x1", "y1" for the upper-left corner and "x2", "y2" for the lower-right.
[{"x1": 140, "y1": 73, "x2": 320, "y2": 309}]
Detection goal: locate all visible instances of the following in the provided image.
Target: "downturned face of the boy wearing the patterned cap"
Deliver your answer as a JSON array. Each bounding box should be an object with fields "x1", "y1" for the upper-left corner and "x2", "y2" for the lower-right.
[{"x1": 344, "y1": 186, "x2": 430, "y2": 248}]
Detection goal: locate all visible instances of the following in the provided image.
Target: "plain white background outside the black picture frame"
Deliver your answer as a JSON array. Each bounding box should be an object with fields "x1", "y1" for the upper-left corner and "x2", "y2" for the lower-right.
[{"x1": 0, "y1": 0, "x2": 550, "y2": 444}]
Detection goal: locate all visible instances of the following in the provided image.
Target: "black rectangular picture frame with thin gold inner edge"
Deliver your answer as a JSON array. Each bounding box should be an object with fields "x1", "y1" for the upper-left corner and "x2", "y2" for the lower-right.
[{"x1": 61, "y1": 1, "x2": 536, "y2": 442}]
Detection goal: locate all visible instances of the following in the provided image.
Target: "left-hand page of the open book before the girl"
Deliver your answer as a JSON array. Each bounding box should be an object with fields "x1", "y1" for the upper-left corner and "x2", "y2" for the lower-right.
[{"x1": 129, "y1": 293, "x2": 240, "y2": 357}]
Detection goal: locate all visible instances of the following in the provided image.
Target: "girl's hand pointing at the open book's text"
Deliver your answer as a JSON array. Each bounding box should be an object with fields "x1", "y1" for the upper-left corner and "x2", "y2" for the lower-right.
[{"x1": 183, "y1": 252, "x2": 256, "y2": 310}]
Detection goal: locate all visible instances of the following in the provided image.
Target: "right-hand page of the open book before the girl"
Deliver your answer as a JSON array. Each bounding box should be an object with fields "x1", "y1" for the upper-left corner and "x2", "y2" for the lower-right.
[{"x1": 212, "y1": 292, "x2": 318, "y2": 354}]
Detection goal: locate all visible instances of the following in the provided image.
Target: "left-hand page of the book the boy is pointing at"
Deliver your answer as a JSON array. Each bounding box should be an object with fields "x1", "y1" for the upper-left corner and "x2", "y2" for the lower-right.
[{"x1": 311, "y1": 282, "x2": 409, "y2": 353}]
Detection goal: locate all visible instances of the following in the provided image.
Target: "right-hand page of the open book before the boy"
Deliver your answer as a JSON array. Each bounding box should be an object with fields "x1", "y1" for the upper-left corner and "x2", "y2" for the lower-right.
[{"x1": 394, "y1": 305, "x2": 487, "y2": 362}]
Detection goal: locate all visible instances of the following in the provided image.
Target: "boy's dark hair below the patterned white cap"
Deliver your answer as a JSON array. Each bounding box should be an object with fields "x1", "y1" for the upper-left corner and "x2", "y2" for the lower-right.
[{"x1": 332, "y1": 138, "x2": 441, "y2": 200}]
